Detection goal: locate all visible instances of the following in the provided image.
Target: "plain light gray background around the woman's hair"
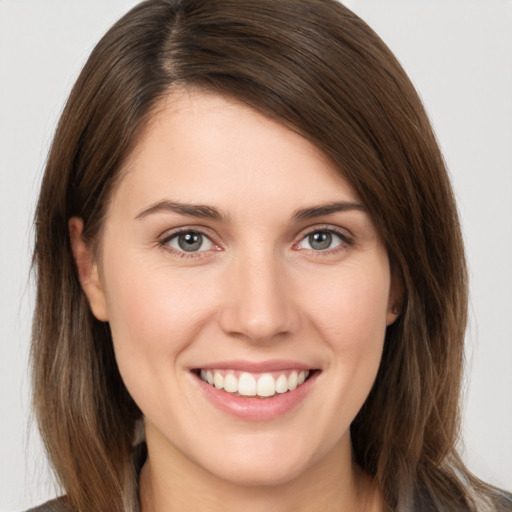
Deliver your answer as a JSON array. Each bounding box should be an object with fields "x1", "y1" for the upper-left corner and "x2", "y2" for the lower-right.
[{"x1": 0, "y1": 0, "x2": 512, "y2": 512}]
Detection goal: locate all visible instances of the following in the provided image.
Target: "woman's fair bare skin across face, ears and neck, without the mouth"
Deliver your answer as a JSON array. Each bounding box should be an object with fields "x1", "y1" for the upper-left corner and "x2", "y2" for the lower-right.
[{"x1": 69, "y1": 91, "x2": 399, "y2": 512}]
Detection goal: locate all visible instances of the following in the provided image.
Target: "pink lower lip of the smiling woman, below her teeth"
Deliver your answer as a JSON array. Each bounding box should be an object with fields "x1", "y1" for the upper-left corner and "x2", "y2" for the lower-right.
[{"x1": 194, "y1": 372, "x2": 319, "y2": 421}]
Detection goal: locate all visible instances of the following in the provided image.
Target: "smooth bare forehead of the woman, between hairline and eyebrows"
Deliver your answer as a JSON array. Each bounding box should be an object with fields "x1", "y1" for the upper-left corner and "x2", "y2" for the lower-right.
[{"x1": 109, "y1": 90, "x2": 357, "y2": 220}]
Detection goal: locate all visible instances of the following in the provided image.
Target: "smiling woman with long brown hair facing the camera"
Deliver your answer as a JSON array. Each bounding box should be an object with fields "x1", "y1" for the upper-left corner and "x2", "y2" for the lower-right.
[{"x1": 29, "y1": 0, "x2": 511, "y2": 511}]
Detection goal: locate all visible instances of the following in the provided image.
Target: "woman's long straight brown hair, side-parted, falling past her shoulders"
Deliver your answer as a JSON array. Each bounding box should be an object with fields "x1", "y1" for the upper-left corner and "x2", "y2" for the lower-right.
[{"x1": 32, "y1": 0, "x2": 511, "y2": 512}]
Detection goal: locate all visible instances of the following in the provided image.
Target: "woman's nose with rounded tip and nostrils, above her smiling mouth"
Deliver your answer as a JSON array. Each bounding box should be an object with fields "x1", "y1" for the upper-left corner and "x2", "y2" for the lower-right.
[{"x1": 220, "y1": 249, "x2": 300, "y2": 343}]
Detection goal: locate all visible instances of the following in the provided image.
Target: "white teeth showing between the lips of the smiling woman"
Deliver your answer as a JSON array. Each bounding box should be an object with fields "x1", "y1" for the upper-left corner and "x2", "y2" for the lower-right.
[{"x1": 195, "y1": 369, "x2": 315, "y2": 398}]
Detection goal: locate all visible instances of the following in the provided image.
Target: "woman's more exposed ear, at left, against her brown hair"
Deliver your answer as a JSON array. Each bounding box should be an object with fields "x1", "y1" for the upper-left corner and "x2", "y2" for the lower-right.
[{"x1": 68, "y1": 217, "x2": 108, "y2": 322}]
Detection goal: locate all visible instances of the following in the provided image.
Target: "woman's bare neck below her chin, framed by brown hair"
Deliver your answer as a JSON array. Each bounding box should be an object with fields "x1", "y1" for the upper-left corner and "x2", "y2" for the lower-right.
[{"x1": 140, "y1": 424, "x2": 382, "y2": 512}]
